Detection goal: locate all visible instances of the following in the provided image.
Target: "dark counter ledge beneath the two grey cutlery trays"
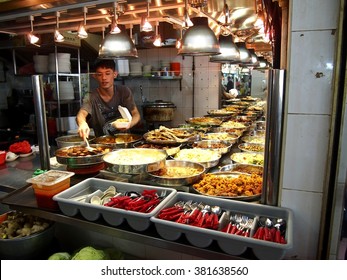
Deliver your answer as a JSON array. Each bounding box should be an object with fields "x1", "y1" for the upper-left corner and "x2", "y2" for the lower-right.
[{"x1": 1, "y1": 176, "x2": 251, "y2": 259}]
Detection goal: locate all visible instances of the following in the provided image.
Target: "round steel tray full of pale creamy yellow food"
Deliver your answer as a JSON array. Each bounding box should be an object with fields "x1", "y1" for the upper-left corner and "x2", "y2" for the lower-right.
[{"x1": 102, "y1": 148, "x2": 167, "y2": 174}]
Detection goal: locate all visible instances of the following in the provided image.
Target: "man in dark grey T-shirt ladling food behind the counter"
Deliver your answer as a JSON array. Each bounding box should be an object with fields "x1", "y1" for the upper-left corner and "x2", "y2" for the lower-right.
[{"x1": 76, "y1": 60, "x2": 141, "y2": 138}]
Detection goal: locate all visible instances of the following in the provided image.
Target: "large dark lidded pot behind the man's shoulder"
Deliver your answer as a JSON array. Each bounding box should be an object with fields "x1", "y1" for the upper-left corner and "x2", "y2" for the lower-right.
[{"x1": 142, "y1": 100, "x2": 176, "y2": 122}]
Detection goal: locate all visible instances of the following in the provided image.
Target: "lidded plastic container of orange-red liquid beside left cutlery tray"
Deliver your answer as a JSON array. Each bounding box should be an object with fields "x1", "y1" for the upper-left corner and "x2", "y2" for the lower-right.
[{"x1": 27, "y1": 170, "x2": 75, "y2": 210}]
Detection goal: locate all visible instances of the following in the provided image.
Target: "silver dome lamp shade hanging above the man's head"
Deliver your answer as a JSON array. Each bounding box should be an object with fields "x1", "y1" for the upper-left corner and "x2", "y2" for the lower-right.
[{"x1": 99, "y1": 32, "x2": 138, "y2": 59}]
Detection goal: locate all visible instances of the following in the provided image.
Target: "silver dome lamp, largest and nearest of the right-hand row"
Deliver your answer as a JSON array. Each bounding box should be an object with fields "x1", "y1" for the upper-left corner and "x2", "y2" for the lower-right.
[{"x1": 178, "y1": 17, "x2": 221, "y2": 56}]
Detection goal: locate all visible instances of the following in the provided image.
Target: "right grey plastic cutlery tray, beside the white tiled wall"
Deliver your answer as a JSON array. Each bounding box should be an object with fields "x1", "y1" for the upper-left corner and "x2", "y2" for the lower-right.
[{"x1": 150, "y1": 192, "x2": 293, "y2": 260}]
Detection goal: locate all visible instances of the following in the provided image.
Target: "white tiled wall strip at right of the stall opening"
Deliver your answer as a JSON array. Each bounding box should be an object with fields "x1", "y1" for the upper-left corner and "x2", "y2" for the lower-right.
[{"x1": 281, "y1": 0, "x2": 339, "y2": 259}]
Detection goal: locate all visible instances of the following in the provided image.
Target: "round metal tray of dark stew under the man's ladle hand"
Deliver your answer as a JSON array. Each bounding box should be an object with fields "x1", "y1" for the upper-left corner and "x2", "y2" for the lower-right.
[{"x1": 55, "y1": 144, "x2": 112, "y2": 167}]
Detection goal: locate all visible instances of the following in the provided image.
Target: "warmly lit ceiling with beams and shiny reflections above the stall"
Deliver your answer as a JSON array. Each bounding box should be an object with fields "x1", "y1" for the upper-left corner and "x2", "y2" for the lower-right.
[{"x1": 0, "y1": 0, "x2": 276, "y2": 63}]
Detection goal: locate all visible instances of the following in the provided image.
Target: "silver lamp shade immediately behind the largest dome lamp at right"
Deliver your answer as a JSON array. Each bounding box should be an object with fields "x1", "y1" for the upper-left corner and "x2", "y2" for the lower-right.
[{"x1": 210, "y1": 35, "x2": 240, "y2": 64}]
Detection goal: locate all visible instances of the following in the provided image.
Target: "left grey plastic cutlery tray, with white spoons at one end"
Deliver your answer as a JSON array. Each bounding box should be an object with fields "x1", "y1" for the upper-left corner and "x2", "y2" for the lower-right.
[{"x1": 53, "y1": 178, "x2": 177, "y2": 231}]
